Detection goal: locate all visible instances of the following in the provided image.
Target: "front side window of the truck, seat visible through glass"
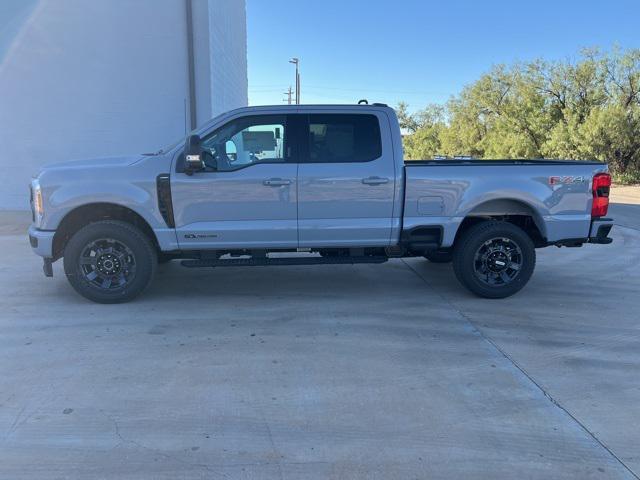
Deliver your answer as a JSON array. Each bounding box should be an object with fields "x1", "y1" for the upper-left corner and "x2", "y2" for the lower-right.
[{"x1": 202, "y1": 115, "x2": 287, "y2": 171}]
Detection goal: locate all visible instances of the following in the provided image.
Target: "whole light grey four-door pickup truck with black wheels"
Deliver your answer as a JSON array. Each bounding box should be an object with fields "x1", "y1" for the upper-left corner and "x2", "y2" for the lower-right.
[{"x1": 29, "y1": 104, "x2": 613, "y2": 303}]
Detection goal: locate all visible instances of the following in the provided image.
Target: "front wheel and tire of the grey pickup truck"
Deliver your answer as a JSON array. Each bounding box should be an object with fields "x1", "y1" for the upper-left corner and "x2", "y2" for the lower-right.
[{"x1": 64, "y1": 220, "x2": 158, "y2": 303}]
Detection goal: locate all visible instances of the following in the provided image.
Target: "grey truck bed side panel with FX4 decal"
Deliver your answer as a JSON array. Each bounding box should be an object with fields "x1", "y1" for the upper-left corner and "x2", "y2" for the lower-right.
[{"x1": 402, "y1": 159, "x2": 607, "y2": 247}]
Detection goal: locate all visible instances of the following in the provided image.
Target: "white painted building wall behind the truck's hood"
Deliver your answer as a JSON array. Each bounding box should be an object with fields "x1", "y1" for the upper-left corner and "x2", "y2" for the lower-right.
[{"x1": 0, "y1": 0, "x2": 247, "y2": 209}]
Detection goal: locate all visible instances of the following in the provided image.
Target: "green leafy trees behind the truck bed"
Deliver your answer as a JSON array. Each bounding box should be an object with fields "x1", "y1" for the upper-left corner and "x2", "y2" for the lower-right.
[{"x1": 398, "y1": 49, "x2": 640, "y2": 182}]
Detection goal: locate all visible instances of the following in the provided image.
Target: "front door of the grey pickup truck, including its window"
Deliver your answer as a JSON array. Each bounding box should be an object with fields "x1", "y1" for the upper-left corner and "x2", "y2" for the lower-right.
[{"x1": 171, "y1": 115, "x2": 298, "y2": 250}]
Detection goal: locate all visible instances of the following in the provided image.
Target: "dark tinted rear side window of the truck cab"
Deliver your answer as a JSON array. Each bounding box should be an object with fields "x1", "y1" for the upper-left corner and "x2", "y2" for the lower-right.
[{"x1": 309, "y1": 114, "x2": 382, "y2": 163}]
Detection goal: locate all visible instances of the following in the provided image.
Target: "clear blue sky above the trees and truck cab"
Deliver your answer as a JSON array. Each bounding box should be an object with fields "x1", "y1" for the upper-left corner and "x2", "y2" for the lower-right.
[{"x1": 247, "y1": 0, "x2": 640, "y2": 109}]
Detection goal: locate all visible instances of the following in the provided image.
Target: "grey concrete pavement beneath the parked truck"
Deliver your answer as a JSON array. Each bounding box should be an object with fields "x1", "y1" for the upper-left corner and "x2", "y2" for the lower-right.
[{"x1": 0, "y1": 189, "x2": 640, "y2": 479}]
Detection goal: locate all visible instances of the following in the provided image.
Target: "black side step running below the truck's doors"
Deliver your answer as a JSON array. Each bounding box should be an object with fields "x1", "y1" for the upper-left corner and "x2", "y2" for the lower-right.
[{"x1": 180, "y1": 256, "x2": 389, "y2": 268}]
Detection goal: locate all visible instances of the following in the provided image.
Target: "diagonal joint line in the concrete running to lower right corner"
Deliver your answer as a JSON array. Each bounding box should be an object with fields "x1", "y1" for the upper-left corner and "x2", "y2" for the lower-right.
[{"x1": 400, "y1": 258, "x2": 640, "y2": 480}]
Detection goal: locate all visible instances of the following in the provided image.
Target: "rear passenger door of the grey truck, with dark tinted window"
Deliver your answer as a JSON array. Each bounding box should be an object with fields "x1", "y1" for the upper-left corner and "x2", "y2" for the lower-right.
[{"x1": 298, "y1": 112, "x2": 396, "y2": 247}]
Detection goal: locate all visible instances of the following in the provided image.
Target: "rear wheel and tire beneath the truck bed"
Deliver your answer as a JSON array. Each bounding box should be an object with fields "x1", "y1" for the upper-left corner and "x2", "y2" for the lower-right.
[{"x1": 453, "y1": 220, "x2": 536, "y2": 298}]
